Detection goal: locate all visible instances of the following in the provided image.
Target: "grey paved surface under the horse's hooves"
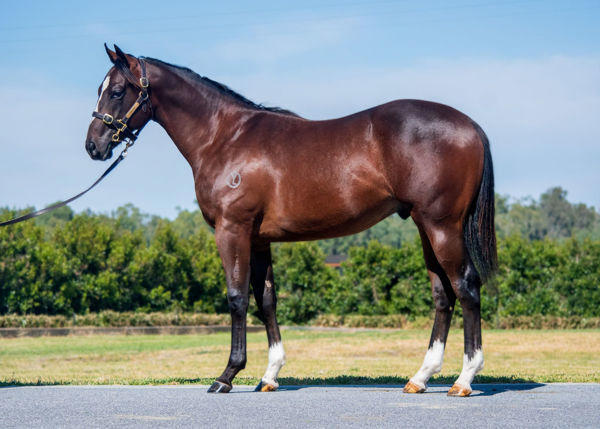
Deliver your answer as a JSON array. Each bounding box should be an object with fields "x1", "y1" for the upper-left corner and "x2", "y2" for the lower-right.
[{"x1": 0, "y1": 384, "x2": 600, "y2": 428}]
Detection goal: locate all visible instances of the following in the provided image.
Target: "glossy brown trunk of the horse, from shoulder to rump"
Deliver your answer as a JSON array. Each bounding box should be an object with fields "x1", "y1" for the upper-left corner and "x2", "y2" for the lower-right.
[{"x1": 209, "y1": 100, "x2": 482, "y2": 240}]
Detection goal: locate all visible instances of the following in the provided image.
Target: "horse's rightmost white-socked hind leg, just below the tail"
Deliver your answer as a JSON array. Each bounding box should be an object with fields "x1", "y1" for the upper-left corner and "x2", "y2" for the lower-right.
[{"x1": 427, "y1": 222, "x2": 483, "y2": 396}]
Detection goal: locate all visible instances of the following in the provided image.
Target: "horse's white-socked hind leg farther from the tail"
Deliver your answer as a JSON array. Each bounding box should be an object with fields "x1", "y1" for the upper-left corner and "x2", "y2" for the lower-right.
[{"x1": 403, "y1": 227, "x2": 456, "y2": 393}]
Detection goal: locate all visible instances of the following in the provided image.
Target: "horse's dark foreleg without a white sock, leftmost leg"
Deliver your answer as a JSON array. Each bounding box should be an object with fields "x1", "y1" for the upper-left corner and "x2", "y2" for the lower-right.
[{"x1": 208, "y1": 222, "x2": 250, "y2": 393}]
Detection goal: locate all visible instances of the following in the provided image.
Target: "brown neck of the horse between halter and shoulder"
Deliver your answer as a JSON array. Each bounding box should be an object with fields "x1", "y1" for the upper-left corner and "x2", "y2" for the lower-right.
[{"x1": 148, "y1": 63, "x2": 243, "y2": 167}]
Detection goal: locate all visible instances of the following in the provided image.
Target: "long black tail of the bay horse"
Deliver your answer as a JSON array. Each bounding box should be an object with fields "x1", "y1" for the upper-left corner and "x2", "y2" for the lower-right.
[{"x1": 463, "y1": 122, "x2": 498, "y2": 283}]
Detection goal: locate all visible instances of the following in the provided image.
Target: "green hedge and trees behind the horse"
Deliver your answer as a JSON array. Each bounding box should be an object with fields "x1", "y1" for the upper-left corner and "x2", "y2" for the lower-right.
[{"x1": 0, "y1": 188, "x2": 600, "y2": 323}]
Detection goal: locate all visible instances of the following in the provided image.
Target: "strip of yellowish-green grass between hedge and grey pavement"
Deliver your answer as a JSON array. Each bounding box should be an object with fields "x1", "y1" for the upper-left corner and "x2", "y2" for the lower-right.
[{"x1": 0, "y1": 330, "x2": 600, "y2": 386}]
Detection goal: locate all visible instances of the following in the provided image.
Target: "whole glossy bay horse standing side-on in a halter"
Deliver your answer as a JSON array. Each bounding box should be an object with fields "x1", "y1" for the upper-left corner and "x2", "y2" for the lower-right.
[{"x1": 85, "y1": 45, "x2": 497, "y2": 396}]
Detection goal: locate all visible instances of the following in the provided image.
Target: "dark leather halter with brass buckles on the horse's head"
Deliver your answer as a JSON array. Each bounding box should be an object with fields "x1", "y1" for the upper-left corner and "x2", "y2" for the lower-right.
[{"x1": 92, "y1": 58, "x2": 154, "y2": 146}]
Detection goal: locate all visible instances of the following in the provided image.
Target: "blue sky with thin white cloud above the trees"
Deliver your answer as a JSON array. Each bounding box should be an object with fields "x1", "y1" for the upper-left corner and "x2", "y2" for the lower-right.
[{"x1": 0, "y1": 0, "x2": 600, "y2": 218}]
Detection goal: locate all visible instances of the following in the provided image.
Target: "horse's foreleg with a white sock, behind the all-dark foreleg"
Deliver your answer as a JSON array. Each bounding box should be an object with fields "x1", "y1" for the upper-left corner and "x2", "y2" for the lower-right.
[{"x1": 250, "y1": 244, "x2": 285, "y2": 392}]
